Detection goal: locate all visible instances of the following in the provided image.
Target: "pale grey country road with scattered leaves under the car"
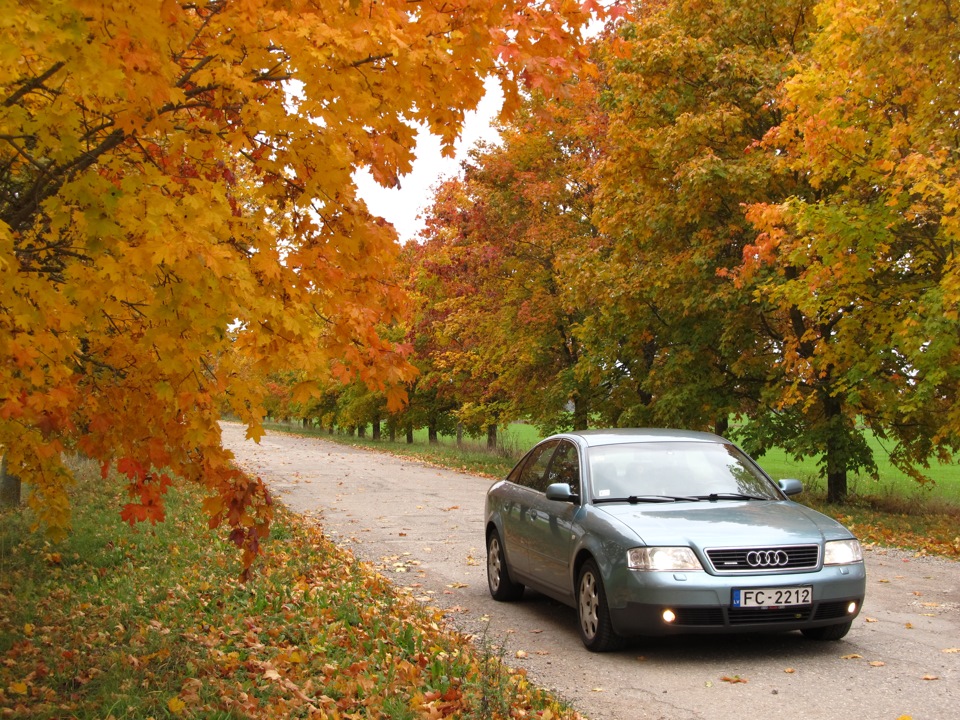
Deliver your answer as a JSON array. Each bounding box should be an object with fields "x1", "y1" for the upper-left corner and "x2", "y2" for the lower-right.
[{"x1": 223, "y1": 424, "x2": 960, "y2": 720}]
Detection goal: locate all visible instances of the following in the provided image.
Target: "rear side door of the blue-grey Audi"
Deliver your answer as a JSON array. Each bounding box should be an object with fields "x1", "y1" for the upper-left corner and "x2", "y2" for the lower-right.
[{"x1": 501, "y1": 440, "x2": 559, "y2": 575}]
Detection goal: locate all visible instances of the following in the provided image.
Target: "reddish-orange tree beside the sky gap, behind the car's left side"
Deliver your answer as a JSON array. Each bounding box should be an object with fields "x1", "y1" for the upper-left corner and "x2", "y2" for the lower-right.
[{"x1": 412, "y1": 77, "x2": 604, "y2": 438}]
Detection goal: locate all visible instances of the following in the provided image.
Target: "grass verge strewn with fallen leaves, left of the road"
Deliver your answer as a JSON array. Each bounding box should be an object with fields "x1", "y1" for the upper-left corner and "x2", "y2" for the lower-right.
[{"x1": 0, "y1": 464, "x2": 579, "y2": 720}]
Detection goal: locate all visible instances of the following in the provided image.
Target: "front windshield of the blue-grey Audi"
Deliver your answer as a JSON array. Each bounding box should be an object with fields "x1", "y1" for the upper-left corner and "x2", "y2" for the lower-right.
[{"x1": 589, "y1": 442, "x2": 783, "y2": 503}]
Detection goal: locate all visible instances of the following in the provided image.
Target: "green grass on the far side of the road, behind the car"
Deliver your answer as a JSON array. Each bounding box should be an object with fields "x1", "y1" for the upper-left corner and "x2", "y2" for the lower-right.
[{"x1": 268, "y1": 423, "x2": 960, "y2": 557}]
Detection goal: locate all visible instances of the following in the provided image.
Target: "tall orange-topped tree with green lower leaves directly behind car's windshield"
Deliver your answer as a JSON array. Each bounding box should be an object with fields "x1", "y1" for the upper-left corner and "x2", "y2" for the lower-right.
[{"x1": 591, "y1": 0, "x2": 813, "y2": 433}]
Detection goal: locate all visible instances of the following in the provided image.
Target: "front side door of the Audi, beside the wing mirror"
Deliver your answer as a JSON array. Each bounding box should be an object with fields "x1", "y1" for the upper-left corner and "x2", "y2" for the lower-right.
[{"x1": 525, "y1": 440, "x2": 581, "y2": 595}]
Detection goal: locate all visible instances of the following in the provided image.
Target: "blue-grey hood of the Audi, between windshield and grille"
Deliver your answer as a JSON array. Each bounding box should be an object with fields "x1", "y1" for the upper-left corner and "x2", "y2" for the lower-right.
[{"x1": 595, "y1": 501, "x2": 851, "y2": 547}]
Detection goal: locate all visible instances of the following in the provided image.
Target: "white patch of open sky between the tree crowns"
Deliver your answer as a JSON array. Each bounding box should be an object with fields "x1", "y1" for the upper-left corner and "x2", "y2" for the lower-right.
[{"x1": 355, "y1": 80, "x2": 503, "y2": 243}]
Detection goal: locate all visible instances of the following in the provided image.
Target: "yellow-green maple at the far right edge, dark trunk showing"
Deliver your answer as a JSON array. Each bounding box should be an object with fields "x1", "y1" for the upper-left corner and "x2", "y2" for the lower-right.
[{"x1": 740, "y1": 0, "x2": 960, "y2": 499}]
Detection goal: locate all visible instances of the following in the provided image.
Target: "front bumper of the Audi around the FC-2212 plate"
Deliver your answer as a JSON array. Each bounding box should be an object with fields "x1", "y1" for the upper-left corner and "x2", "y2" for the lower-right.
[{"x1": 607, "y1": 563, "x2": 866, "y2": 636}]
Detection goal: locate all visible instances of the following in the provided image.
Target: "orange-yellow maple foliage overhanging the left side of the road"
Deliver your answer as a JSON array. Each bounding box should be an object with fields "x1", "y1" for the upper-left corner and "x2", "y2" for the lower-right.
[{"x1": 0, "y1": 0, "x2": 592, "y2": 562}]
